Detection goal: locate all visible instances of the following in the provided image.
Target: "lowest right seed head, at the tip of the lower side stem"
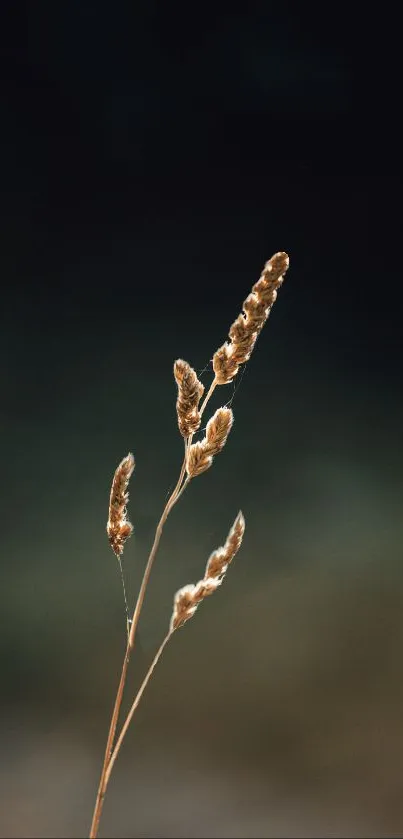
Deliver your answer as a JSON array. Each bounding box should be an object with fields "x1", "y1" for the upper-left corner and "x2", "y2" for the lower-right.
[{"x1": 169, "y1": 512, "x2": 245, "y2": 633}]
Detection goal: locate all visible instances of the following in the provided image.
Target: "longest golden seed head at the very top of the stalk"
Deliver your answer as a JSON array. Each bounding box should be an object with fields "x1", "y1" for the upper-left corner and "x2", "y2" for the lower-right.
[{"x1": 213, "y1": 252, "x2": 289, "y2": 385}]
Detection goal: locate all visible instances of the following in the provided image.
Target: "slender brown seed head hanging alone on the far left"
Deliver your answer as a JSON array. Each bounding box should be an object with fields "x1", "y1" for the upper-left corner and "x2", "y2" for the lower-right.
[{"x1": 106, "y1": 452, "x2": 134, "y2": 557}]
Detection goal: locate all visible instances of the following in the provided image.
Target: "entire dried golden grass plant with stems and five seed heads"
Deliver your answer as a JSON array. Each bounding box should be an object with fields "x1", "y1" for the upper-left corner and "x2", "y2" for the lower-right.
[{"x1": 90, "y1": 252, "x2": 289, "y2": 839}]
